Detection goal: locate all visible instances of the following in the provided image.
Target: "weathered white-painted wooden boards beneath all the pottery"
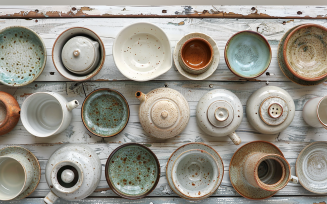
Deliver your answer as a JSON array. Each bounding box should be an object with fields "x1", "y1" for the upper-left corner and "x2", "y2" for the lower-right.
[{"x1": 0, "y1": 6, "x2": 327, "y2": 204}]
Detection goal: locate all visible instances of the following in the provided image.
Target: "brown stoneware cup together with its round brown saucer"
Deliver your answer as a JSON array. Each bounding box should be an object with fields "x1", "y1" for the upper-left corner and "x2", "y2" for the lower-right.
[{"x1": 229, "y1": 141, "x2": 297, "y2": 200}]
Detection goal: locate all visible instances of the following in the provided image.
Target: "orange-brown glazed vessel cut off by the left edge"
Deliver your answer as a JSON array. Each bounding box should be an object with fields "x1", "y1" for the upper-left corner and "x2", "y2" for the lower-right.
[{"x1": 0, "y1": 91, "x2": 20, "y2": 135}]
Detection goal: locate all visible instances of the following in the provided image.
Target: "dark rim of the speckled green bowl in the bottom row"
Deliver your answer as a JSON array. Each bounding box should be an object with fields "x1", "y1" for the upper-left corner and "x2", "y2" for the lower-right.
[{"x1": 105, "y1": 143, "x2": 161, "y2": 200}]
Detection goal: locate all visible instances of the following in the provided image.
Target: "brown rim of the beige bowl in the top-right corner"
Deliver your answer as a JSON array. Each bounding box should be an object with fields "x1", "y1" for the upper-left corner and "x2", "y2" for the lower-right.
[{"x1": 283, "y1": 23, "x2": 327, "y2": 81}]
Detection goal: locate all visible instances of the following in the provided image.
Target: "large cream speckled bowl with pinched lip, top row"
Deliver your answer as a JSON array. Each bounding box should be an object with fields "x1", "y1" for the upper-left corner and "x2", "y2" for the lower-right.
[{"x1": 112, "y1": 23, "x2": 172, "y2": 81}]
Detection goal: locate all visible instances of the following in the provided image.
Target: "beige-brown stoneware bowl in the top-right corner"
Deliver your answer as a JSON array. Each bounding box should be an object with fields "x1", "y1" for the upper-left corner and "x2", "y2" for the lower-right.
[{"x1": 283, "y1": 24, "x2": 327, "y2": 81}]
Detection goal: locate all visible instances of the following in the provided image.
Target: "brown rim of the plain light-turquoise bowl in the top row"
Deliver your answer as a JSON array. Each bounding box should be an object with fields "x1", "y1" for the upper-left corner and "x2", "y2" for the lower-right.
[{"x1": 224, "y1": 30, "x2": 272, "y2": 79}]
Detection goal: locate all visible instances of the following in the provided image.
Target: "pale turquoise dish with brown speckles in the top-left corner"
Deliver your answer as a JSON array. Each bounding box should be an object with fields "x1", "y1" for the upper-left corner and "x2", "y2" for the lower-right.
[{"x1": 0, "y1": 26, "x2": 47, "y2": 86}]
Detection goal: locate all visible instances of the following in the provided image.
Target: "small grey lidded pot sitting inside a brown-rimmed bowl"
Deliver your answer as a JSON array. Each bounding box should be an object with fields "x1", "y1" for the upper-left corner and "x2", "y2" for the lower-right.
[{"x1": 61, "y1": 36, "x2": 100, "y2": 75}]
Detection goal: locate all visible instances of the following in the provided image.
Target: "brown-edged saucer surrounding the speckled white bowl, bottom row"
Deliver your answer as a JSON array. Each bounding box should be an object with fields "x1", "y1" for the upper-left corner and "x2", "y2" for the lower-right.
[{"x1": 166, "y1": 142, "x2": 224, "y2": 200}]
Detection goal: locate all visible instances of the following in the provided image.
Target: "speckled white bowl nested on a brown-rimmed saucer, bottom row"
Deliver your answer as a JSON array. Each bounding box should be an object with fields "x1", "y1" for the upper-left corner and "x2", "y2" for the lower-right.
[{"x1": 171, "y1": 149, "x2": 219, "y2": 200}]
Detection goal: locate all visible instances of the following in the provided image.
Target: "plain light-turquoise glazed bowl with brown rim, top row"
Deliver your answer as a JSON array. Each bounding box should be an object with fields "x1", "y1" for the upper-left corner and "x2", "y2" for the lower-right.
[{"x1": 225, "y1": 31, "x2": 271, "y2": 79}]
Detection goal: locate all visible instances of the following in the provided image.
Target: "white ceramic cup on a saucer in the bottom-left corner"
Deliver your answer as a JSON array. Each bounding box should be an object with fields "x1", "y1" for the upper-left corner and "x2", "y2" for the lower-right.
[{"x1": 0, "y1": 153, "x2": 33, "y2": 200}]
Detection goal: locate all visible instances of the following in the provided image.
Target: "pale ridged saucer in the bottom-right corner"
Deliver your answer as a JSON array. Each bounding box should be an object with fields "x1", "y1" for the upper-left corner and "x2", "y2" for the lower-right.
[{"x1": 296, "y1": 141, "x2": 327, "y2": 194}]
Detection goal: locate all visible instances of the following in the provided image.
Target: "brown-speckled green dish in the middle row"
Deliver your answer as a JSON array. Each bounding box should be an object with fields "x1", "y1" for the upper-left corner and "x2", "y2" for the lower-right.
[{"x1": 82, "y1": 88, "x2": 129, "y2": 137}]
